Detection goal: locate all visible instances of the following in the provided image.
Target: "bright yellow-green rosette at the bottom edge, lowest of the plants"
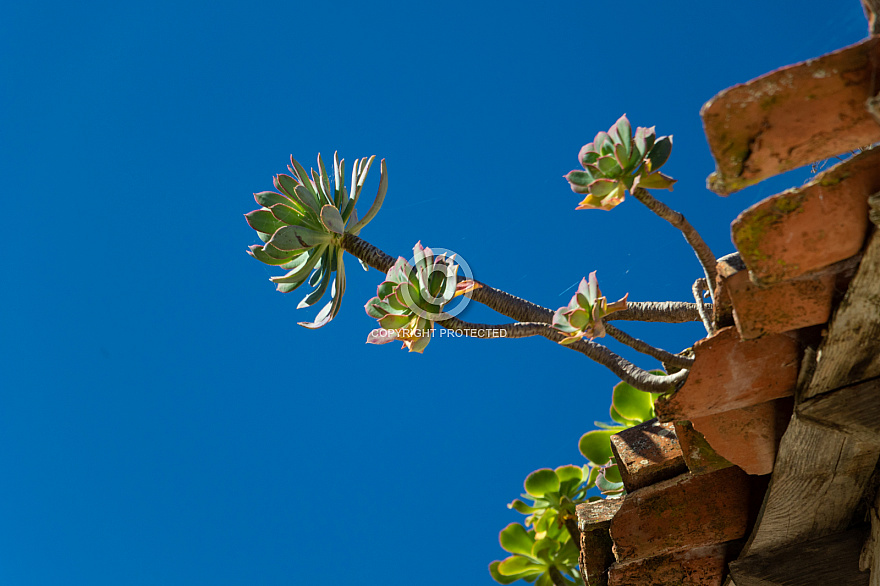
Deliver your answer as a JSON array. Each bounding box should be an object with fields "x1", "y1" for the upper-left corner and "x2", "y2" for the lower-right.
[{"x1": 489, "y1": 523, "x2": 580, "y2": 586}]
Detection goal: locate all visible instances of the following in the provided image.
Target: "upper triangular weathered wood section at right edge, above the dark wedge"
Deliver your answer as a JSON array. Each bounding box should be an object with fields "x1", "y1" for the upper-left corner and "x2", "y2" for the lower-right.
[{"x1": 800, "y1": 230, "x2": 880, "y2": 400}]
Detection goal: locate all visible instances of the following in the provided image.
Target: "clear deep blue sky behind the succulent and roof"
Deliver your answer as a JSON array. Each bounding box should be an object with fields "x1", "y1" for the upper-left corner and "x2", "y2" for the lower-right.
[{"x1": 0, "y1": 0, "x2": 867, "y2": 586}]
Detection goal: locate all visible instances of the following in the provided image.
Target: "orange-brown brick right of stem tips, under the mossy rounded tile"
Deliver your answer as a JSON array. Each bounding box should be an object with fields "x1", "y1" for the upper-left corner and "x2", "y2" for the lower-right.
[{"x1": 721, "y1": 264, "x2": 836, "y2": 340}]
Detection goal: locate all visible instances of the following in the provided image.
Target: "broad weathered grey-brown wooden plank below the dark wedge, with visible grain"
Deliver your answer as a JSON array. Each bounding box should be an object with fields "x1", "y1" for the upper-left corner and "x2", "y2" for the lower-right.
[{"x1": 739, "y1": 414, "x2": 878, "y2": 556}]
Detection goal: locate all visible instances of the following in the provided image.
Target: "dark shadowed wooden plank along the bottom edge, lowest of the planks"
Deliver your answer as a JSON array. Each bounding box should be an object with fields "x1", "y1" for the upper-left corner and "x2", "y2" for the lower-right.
[{"x1": 729, "y1": 529, "x2": 869, "y2": 586}]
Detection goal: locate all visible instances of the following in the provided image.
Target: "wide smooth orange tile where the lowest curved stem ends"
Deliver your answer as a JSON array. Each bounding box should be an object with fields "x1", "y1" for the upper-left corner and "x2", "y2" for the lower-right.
[{"x1": 655, "y1": 327, "x2": 800, "y2": 420}]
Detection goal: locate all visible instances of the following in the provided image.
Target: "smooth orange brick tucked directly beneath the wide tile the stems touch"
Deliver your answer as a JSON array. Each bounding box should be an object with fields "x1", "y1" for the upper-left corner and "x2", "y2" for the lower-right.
[{"x1": 691, "y1": 397, "x2": 794, "y2": 475}]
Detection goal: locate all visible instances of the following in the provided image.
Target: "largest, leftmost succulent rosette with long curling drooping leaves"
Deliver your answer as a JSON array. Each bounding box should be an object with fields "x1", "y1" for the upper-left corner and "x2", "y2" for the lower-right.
[{"x1": 245, "y1": 153, "x2": 388, "y2": 328}]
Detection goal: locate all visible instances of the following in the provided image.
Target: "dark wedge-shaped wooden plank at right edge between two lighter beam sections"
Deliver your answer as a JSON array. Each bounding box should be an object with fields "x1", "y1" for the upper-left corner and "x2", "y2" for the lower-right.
[{"x1": 798, "y1": 378, "x2": 880, "y2": 443}]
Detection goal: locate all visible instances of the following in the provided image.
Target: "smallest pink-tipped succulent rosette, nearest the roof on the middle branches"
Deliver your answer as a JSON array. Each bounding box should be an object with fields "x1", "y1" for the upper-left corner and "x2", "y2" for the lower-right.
[{"x1": 551, "y1": 271, "x2": 629, "y2": 345}]
